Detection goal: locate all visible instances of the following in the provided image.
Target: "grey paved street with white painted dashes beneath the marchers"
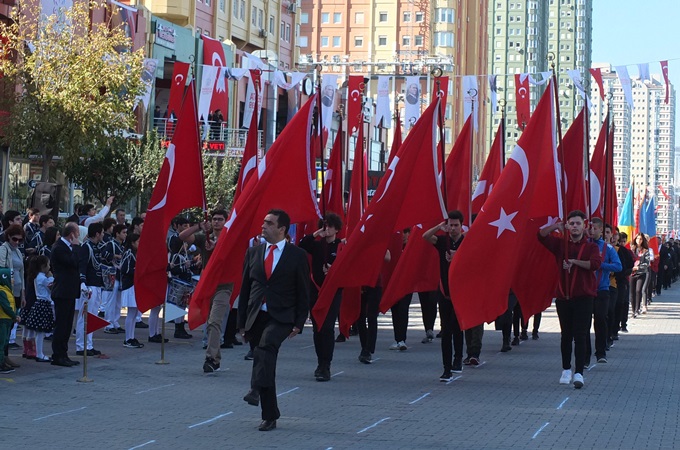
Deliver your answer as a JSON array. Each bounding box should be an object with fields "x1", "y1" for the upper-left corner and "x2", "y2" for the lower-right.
[{"x1": 5, "y1": 284, "x2": 680, "y2": 449}]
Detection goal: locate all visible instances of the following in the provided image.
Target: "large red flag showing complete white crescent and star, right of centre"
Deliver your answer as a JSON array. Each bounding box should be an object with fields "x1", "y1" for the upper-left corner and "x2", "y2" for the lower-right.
[{"x1": 449, "y1": 82, "x2": 559, "y2": 329}]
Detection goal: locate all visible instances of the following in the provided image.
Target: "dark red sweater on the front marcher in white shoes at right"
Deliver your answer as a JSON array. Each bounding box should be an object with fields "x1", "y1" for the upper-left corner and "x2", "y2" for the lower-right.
[{"x1": 538, "y1": 232, "x2": 602, "y2": 298}]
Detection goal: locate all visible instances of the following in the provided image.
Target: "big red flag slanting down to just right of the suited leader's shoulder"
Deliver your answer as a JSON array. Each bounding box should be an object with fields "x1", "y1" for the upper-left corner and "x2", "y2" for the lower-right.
[{"x1": 312, "y1": 101, "x2": 446, "y2": 323}]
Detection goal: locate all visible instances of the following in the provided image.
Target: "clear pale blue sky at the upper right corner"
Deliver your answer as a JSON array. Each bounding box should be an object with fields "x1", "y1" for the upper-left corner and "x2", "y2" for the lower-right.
[{"x1": 592, "y1": 0, "x2": 680, "y2": 146}]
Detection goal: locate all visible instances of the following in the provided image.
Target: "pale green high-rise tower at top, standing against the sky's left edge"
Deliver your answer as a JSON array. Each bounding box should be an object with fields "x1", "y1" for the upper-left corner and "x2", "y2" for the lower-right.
[{"x1": 487, "y1": 0, "x2": 592, "y2": 156}]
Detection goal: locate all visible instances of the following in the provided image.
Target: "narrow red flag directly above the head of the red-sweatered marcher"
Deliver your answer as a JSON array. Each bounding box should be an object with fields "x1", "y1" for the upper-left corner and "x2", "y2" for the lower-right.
[{"x1": 560, "y1": 106, "x2": 586, "y2": 214}]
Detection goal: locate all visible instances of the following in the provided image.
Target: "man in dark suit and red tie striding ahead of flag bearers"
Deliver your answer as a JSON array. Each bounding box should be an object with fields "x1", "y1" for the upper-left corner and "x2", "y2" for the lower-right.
[{"x1": 238, "y1": 209, "x2": 309, "y2": 431}]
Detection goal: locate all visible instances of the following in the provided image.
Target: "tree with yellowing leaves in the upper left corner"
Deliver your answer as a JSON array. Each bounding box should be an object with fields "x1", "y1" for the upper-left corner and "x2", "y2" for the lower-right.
[{"x1": 0, "y1": 0, "x2": 145, "y2": 181}]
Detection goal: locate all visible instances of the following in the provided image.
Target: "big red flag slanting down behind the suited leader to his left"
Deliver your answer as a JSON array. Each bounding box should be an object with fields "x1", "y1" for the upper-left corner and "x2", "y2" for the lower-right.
[{"x1": 187, "y1": 95, "x2": 320, "y2": 329}]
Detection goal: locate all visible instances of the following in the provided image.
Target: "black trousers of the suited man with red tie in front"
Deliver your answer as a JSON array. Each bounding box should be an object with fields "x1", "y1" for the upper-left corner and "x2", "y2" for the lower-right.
[{"x1": 246, "y1": 311, "x2": 293, "y2": 420}]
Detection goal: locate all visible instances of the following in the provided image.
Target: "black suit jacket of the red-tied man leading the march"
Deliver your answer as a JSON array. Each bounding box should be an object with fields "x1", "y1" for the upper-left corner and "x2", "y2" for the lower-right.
[{"x1": 238, "y1": 243, "x2": 309, "y2": 331}]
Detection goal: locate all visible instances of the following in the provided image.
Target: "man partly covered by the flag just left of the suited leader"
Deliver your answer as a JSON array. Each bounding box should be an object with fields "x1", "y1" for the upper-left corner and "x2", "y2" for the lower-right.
[{"x1": 175, "y1": 209, "x2": 234, "y2": 373}]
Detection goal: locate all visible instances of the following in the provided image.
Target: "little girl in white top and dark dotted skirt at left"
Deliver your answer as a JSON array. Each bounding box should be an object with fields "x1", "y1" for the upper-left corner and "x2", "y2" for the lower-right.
[{"x1": 24, "y1": 255, "x2": 54, "y2": 362}]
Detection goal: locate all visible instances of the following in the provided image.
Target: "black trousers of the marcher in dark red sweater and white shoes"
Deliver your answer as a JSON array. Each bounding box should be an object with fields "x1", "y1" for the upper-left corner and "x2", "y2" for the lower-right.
[{"x1": 555, "y1": 297, "x2": 593, "y2": 375}]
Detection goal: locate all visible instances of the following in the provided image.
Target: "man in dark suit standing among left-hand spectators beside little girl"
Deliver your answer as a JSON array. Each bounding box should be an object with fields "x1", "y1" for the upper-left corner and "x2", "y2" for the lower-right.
[{"x1": 50, "y1": 222, "x2": 80, "y2": 367}]
